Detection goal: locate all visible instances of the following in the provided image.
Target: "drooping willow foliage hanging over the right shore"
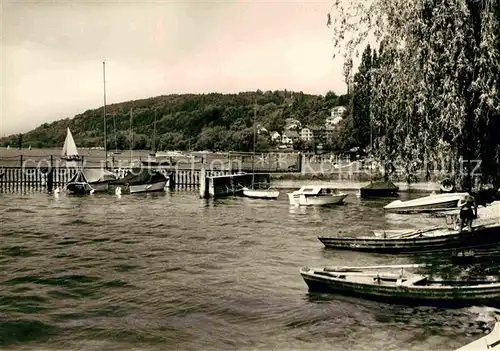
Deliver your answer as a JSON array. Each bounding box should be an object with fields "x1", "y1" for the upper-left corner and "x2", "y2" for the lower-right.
[{"x1": 330, "y1": 0, "x2": 500, "y2": 190}]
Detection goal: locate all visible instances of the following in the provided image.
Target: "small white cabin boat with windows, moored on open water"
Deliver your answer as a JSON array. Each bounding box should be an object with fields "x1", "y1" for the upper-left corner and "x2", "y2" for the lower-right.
[{"x1": 288, "y1": 184, "x2": 347, "y2": 206}]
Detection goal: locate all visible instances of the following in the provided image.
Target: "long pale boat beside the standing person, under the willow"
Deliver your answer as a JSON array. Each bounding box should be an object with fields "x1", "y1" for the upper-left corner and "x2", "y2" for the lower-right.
[{"x1": 384, "y1": 193, "x2": 468, "y2": 213}]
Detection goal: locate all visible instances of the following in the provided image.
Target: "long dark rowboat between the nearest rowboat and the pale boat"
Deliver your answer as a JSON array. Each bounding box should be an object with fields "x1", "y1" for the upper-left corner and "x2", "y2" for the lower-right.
[{"x1": 318, "y1": 222, "x2": 500, "y2": 254}]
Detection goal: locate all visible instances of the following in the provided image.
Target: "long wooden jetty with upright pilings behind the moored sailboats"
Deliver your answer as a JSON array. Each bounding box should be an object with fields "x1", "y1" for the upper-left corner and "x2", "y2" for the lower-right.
[{"x1": 0, "y1": 153, "x2": 300, "y2": 198}]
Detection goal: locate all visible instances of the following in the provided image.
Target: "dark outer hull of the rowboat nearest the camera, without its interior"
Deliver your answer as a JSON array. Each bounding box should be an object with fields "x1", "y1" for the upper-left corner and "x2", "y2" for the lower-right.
[{"x1": 300, "y1": 267, "x2": 500, "y2": 306}]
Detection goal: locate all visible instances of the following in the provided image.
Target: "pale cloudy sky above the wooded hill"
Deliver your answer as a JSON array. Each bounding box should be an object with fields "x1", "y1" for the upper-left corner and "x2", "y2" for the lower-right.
[{"x1": 0, "y1": 0, "x2": 346, "y2": 137}]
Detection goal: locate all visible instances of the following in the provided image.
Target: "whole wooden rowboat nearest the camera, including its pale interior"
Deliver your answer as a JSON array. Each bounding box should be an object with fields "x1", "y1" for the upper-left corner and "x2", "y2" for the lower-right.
[{"x1": 300, "y1": 265, "x2": 500, "y2": 306}]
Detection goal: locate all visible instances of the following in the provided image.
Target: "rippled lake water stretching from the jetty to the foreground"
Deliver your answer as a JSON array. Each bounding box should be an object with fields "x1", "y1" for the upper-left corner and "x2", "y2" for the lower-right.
[{"x1": 0, "y1": 192, "x2": 495, "y2": 350}]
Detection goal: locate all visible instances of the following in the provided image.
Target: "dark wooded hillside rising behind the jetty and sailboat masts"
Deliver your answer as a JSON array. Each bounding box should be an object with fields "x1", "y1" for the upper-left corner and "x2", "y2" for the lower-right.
[{"x1": 0, "y1": 90, "x2": 347, "y2": 151}]
